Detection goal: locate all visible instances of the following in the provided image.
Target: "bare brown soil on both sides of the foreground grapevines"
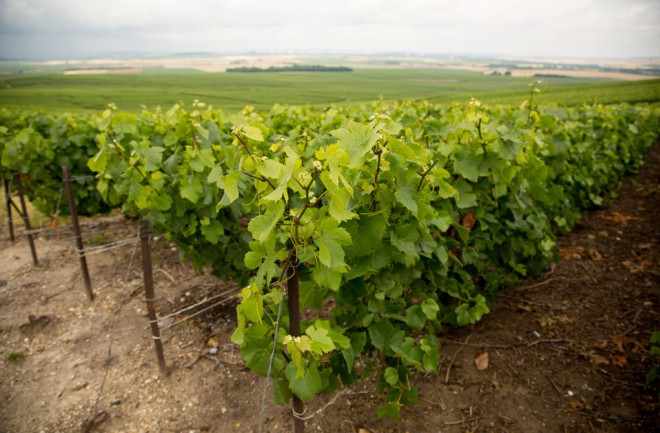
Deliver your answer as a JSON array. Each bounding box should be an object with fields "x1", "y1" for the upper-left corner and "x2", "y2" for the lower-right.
[{"x1": 0, "y1": 146, "x2": 660, "y2": 433}]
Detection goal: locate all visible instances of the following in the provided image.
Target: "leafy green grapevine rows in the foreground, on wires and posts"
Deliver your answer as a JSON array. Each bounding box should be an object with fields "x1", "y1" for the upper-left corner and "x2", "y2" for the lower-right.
[{"x1": 0, "y1": 96, "x2": 660, "y2": 431}]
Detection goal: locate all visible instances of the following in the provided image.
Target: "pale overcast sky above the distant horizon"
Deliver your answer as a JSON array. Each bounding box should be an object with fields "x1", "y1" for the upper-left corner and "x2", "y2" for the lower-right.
[{"x1": 0, "y1": 0, "x2": 660, "y2": 59}]
